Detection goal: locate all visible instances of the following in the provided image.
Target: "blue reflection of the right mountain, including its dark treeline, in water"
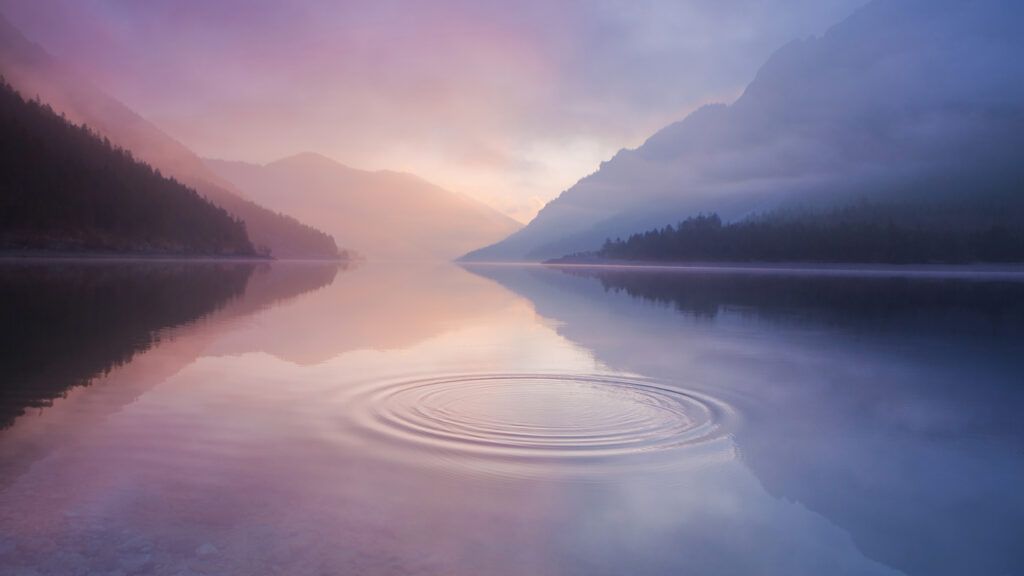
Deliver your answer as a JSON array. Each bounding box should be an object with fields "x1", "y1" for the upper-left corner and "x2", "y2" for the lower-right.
[{"x1": 471, "y1": 266, "x2": 1024, "y2": 575}]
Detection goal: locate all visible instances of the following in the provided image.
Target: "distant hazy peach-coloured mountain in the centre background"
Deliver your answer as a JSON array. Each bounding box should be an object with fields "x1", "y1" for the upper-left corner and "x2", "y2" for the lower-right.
[{"x1": 207, "y1": 154, "x2": 520, "y2": 260}]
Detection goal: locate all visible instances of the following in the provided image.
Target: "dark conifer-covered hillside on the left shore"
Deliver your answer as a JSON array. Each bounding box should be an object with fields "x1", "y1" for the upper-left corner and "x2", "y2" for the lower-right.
[{"x1": 0, "y1": 78, "x2": 256, "y2": 255}]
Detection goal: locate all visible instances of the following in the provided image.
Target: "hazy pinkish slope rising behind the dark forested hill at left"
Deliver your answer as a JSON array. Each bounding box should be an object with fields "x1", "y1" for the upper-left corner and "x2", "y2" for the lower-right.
[{"x1": 0, "y1": 13, "x2": 339, "y2": 258}]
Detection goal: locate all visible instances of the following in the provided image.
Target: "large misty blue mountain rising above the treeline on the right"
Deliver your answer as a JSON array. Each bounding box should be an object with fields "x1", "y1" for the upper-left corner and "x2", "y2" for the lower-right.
[{"x1": 466, "y1": 0, "x2": 1024, "y2": 260}]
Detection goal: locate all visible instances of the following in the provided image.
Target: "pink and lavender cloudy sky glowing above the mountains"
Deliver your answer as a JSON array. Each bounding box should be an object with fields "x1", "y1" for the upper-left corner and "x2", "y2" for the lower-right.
[{"x1": 0, "y1": 0, "x2": 865, "y2": 221}]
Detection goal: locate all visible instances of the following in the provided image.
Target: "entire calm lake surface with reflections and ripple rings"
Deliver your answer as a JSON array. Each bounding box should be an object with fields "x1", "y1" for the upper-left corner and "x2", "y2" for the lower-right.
[{"x1": 0, "y1": 263, "x2": 1024, "y2": 575}]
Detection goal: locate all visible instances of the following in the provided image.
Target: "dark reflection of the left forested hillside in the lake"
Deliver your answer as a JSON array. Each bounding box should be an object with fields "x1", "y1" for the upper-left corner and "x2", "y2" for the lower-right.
[{"x1": 0, "y1": 262, "x2": 337, "y2": 427}]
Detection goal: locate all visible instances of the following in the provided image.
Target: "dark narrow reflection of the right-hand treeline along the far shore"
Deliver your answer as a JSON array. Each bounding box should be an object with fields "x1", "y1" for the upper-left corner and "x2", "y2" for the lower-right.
[{"x1": 565, "y1": 268, "x2": 1024, "y2": 336}]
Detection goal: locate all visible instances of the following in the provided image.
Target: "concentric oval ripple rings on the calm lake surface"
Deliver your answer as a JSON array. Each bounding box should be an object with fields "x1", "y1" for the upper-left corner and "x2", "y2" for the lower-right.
[{"x1": 349, "y1": 374, "x2": 735, "y2": 479}]
